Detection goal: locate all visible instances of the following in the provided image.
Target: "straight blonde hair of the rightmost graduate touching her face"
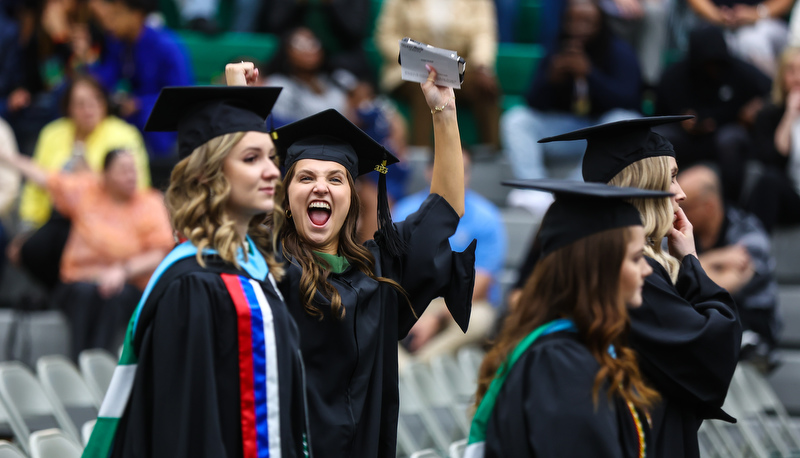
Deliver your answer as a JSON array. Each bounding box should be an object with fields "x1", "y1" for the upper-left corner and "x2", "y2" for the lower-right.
[{"x1": 608, "y1": 156, "x2": 680, "y2": 283}]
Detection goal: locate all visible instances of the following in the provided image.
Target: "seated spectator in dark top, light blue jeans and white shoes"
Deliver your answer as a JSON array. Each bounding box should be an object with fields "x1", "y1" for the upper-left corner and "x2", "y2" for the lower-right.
[{"x1": 500, "y1": 0, "x2": 641, "y2": 215}]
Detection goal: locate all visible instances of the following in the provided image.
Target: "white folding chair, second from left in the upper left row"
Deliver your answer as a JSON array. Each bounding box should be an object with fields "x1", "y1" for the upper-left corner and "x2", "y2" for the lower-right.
[{"x1": 36, "y1": 355, "x2": 100, "y2": 434}]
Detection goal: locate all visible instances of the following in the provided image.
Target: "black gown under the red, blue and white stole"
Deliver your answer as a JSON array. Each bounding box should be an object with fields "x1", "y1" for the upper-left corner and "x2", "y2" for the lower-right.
[{"x1": 111, "y1": 256, "x2": 304, "y2": 458}]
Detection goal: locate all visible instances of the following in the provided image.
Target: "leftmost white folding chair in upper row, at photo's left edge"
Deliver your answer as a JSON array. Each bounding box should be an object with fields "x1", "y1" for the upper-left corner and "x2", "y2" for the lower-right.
[{"x1": 0, "y1": 361, "x2": 79, "y2": 453}]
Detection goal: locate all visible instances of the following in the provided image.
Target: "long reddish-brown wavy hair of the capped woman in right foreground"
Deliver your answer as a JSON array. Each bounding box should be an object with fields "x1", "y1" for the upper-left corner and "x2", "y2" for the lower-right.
[{"x1": 475, "y1": 228, "x2": 659, "y2": 408}]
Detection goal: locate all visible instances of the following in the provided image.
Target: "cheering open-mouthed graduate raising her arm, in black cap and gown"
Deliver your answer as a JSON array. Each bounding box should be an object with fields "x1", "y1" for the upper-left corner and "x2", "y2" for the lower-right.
[{"x1": 227, "y1": 63, "x2": 475, "y2": 457}]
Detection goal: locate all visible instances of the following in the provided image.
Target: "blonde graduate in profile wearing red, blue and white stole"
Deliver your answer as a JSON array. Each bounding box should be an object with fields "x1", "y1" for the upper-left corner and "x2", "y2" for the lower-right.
[{"x1": 83, "y1": 87, "x2": 307, "y2": 458}]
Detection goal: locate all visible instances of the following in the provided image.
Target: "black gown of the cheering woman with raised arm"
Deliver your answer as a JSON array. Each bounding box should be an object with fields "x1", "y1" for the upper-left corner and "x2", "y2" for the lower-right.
[{"x1": 279, "y1": 194, "x2": 475, "y2": 458}]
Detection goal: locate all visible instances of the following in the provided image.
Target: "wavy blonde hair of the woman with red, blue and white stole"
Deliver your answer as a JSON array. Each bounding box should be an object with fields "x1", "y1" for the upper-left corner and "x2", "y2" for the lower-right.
[{"x1": 166, "y1": 132, "x2": 283, "y2": 280}]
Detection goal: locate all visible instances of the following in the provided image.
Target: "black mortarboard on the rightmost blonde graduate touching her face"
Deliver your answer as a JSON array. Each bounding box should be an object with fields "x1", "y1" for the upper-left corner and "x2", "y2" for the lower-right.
[{"x1": 539, "y1": 116, "x2": 692, "y2": 183}]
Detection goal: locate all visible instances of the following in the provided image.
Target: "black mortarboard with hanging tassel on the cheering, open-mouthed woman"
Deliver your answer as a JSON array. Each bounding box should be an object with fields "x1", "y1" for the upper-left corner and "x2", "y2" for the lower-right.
[{"x1": 272, "y1": 109, "x2": 405, "y2": 255}]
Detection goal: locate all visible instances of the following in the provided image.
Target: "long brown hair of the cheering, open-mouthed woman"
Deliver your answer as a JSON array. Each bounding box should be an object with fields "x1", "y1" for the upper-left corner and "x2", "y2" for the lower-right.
[{"x1": 268, "y1": 163, "x2": 406, "y2": 320}]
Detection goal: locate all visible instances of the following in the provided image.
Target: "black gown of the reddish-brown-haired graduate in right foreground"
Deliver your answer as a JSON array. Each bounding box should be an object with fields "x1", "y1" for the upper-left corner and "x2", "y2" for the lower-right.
[{"x1": 484, "y1": 331, "x2": 653, "y2": 458}]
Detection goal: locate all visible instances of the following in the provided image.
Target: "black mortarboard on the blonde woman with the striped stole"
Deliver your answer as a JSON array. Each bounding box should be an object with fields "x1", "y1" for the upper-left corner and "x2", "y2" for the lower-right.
[{"x1": 144, "y1": 86, "x2": 281, "y2": 159}]
